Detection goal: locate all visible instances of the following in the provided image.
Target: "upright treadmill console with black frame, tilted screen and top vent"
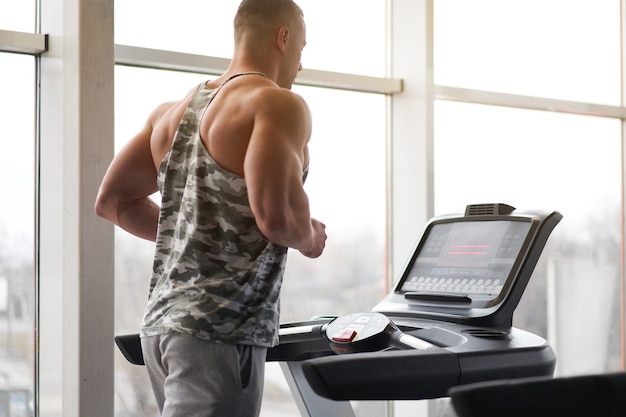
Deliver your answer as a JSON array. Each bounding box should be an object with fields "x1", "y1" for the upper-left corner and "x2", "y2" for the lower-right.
[{"x1": 374, "y1": 204, "x2": 562, "y2": 327}]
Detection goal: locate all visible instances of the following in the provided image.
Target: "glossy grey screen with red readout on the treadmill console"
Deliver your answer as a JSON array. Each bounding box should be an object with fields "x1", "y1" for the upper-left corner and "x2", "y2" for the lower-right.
[{"x1": 400, "y1": 220, "x2": 531, "y2": 298}]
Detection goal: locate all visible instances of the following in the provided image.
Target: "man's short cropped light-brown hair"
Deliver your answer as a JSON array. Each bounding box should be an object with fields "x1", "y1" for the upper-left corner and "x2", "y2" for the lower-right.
[{"x1": 234, "y1": 0, "x2": 304, "y2": 42}]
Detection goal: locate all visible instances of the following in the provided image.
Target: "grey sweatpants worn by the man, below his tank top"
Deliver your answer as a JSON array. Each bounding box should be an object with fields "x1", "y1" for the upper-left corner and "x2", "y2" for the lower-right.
[{"x1": 141, "y1": 335, "x2": 267, "y2": 417}]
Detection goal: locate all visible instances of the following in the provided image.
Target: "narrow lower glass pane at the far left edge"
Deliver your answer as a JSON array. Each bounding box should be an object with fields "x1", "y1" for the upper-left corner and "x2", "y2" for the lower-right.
[{"x1": 0, "y1": 53, "x2": 36, "y2": 416}]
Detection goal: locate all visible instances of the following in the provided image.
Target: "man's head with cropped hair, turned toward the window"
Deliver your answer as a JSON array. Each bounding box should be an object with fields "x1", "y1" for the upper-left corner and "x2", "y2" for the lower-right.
[{"x1": 234, "y1": 0, "x2": 306, "y2": 88}]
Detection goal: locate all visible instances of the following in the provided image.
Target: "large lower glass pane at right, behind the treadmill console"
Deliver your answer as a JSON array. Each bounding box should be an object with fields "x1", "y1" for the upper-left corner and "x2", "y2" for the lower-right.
[{"x1": 435, "y1": 102, "x2": 622, "y2": 375}]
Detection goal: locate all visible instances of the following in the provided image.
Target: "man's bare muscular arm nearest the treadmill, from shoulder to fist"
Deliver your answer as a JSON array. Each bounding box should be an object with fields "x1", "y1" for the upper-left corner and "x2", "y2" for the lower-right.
[{"x1": 244, "y1": 89, "x2": 326, "y2": 258}]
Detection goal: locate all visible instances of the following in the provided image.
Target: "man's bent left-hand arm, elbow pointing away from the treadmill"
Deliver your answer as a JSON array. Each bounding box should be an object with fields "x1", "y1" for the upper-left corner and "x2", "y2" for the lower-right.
[{"x1": 95, "y1": 106, "x2": 163, "y2": 241}]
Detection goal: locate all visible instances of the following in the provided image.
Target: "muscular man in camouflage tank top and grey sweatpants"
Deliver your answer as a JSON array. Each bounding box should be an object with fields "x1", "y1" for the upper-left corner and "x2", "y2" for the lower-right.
[{"x1": 95, "y1": 0, "x2": 326, "y2": 417}]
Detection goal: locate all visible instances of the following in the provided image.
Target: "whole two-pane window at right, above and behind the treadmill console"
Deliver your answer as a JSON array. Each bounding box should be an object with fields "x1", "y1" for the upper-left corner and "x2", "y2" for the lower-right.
[{"x1": 434, "y1": 0, "x2": 624, "y2": 376}]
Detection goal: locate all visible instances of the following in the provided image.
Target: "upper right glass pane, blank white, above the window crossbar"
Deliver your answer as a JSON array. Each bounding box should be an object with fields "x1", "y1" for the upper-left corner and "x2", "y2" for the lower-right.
[{"x1": 434, "y1": 0, "x2": 620, "y2": 105}]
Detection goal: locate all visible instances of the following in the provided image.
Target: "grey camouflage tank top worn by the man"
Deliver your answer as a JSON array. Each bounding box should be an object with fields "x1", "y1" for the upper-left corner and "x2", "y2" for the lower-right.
[{"x1": 141, "y1": 73, "x2": 287, "y2": 347}]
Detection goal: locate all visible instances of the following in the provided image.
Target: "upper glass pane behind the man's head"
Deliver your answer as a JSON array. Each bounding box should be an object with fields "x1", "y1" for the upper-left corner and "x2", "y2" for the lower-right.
[{"x1": 115, "y1": 0, "x2": 385, "y2": 77}]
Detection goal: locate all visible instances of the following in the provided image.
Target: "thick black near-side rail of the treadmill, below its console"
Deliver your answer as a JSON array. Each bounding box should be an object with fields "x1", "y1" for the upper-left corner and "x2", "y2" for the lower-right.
[{"x1": 302, "y1": 343, "x2": 556, "y2": 400}]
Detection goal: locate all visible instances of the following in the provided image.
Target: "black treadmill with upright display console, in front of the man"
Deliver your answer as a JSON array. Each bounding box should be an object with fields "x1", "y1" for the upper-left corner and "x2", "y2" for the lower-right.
[{"x1": 267, "y1": 203, "x2": 562, "y2": 417}]
